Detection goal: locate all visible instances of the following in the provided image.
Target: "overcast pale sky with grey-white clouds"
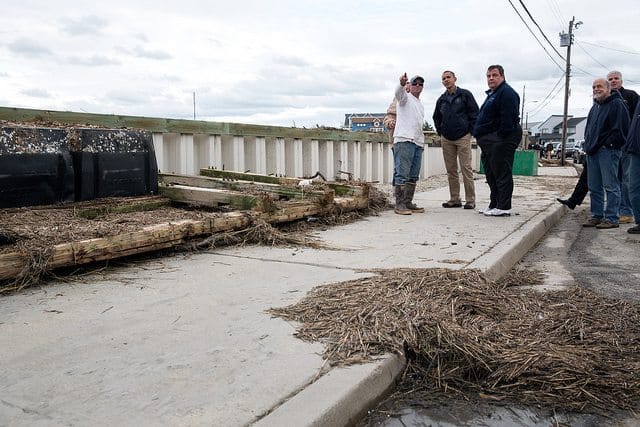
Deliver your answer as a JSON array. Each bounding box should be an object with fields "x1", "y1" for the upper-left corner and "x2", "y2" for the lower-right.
[{"x1": 0, "y1": 0, "x2": 640, "y2": 127}]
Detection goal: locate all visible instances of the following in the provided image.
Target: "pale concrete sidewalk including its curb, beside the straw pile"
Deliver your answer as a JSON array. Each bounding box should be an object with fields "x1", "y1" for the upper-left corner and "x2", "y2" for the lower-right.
[{"x1": 0, "y1": 167, "x2": 576, "y2": 426}]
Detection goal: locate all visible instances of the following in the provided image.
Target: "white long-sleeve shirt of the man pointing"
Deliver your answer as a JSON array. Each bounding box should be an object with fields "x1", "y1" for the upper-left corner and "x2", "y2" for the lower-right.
[{"x1": 393, "y1": 85, "x2": 424, "y2": 147}]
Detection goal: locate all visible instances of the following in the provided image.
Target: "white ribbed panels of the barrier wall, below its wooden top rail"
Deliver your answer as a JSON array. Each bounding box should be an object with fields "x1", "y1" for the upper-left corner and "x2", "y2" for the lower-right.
[{"x1": 153, "y1": 133, "x2": 480, "y2": 183}]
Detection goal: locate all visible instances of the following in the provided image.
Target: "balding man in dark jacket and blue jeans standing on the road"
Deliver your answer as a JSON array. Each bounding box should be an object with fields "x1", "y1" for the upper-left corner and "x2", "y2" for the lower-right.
[{"x1": 582, "y1": 78, "x2": 629, "y2": 229}]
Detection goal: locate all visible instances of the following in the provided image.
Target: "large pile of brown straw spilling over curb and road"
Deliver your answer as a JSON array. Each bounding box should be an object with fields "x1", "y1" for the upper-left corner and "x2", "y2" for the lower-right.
[{"x1": 270, "y1": 269, "x2": 640, "y2": 412}]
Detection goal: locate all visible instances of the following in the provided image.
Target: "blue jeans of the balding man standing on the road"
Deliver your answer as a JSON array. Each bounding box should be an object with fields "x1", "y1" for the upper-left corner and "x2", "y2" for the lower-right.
[{"x1": 587, "y1": 147, "x2": 622, "y2": 224}]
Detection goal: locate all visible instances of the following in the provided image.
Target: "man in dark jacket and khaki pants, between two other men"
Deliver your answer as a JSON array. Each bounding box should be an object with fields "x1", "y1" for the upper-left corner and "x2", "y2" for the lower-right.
[{"x1": 433, "y1": 71, "x2": 478, "y2": 209}]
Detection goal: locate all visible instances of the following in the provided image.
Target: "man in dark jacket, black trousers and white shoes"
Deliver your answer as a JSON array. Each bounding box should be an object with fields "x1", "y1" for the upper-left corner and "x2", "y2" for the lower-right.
[{"x1": 471, "y1": 65, "x2": 522, "y2": 216}]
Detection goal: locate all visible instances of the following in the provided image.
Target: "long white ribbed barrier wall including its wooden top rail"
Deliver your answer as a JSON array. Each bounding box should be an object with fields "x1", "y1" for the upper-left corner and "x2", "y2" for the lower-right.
[{"x1": 0, "y1": 107, "x2": 479, "y2": 183}]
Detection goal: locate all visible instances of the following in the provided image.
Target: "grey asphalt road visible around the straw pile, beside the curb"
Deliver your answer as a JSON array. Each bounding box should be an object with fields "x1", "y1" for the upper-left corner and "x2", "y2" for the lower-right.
[{"x1": 362, "y1": 204, "x2": 640, "y2": 427}]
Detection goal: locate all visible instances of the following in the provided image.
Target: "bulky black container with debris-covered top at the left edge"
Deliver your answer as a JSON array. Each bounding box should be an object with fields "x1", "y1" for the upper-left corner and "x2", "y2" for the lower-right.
[{"x1": 0, "y1": 126, "x2": 158, "y2": 208}]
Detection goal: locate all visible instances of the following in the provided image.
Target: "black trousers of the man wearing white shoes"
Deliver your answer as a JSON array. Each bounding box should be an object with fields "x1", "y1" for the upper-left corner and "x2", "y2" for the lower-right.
[{"x1": 478, "y1": 132, "x2": 520, "y2": 210}]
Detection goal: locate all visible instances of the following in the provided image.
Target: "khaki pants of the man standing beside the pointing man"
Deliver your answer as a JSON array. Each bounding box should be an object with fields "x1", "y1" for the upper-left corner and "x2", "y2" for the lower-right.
[{"x1": 442, "y1": 133, "x2": 476, "y2": 205}]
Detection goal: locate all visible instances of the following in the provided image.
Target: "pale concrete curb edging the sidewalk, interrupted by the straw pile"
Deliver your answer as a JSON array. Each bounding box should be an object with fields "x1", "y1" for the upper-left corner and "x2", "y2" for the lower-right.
[{"x1": 253, "y1": 204, "x2": 567, "y2": 427}]
